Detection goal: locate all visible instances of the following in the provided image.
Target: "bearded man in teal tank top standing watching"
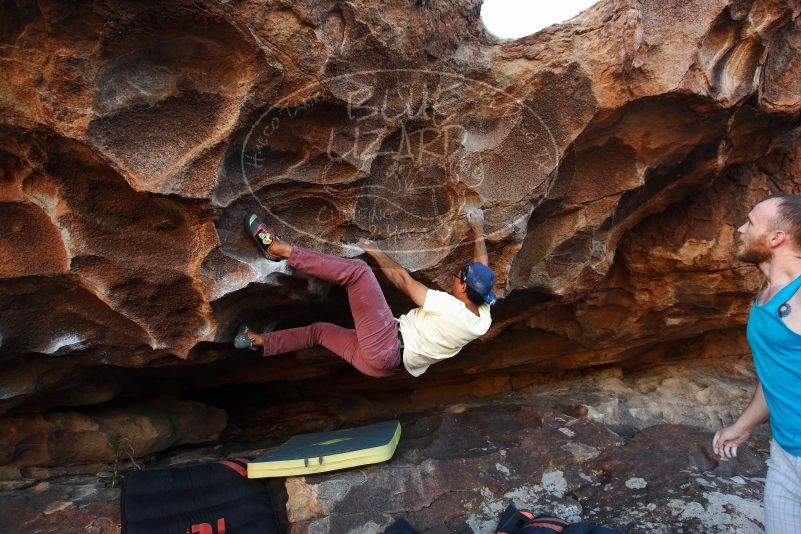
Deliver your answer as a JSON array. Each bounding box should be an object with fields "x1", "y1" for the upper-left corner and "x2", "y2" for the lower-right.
[{"x1": 712, "y1": 195, "x2": 801, "y2": 534}]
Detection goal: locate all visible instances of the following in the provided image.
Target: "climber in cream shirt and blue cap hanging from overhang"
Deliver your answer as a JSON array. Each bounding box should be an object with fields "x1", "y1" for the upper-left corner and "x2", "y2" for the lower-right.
[{"x1": 234, "y1": 208, "x2": 496, "y2": 377}]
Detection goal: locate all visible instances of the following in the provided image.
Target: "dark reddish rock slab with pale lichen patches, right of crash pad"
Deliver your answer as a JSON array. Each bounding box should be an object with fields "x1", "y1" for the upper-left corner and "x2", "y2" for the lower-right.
[{"x1": 287, "y1": 422, "x2": 766, "y2": 534}]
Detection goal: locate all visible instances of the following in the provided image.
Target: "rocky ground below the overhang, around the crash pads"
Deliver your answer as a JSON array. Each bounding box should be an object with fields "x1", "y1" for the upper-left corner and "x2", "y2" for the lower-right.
[{"x1": 0, "y1": 358, "x2": 768, "y2": 534}]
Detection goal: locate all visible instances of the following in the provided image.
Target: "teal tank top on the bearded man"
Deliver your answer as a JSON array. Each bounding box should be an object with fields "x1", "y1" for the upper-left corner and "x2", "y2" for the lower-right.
[{"x1": 747, "y1": 276, "x2": 801, "y2": 456}]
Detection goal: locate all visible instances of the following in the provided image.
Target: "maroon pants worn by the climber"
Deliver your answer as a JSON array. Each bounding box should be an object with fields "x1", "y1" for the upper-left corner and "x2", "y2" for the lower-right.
[{"x1": 262, "y1": 246, "x2": 401, "y2": 377}]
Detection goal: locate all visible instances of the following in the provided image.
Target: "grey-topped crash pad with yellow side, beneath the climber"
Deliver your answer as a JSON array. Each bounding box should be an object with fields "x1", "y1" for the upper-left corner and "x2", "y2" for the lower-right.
[{"x1": 248, "y1": 421, "x2": 400, "y2": 478}]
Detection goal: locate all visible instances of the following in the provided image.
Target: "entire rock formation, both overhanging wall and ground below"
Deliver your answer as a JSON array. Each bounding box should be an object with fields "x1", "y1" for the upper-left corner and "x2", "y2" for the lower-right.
[{"x1": 0, "y1": 0, "x2": 801, "y2": 533}]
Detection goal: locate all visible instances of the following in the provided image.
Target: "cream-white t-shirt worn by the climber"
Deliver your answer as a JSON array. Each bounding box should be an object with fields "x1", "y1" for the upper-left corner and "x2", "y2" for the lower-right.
[{"x1": 397, "y1": 289, "x2": 492, "y2": 376}]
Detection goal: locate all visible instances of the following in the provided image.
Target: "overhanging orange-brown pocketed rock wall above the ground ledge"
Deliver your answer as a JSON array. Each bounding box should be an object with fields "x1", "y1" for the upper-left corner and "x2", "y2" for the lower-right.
[{"x1": 0, "y1": 0, "x2": 801, "y2": 478}]
